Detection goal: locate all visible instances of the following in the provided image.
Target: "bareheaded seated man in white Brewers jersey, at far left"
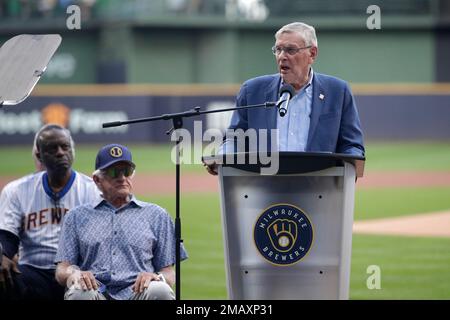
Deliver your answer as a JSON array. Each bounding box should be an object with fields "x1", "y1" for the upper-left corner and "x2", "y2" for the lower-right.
[{"x1": 0, "y1": 125, "x2": 99, "y2": 299}]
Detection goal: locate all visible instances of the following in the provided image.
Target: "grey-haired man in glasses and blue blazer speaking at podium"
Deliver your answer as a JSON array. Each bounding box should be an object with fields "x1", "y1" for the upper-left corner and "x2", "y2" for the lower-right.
[{"x1": 206, "y1": 22, "x2": 364, "y2": 175}]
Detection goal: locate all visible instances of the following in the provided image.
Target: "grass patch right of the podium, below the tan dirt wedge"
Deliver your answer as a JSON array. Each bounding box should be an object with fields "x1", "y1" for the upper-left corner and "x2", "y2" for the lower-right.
[{"x1": 350, "y1": 235, "x2": 450, "y2": 300}]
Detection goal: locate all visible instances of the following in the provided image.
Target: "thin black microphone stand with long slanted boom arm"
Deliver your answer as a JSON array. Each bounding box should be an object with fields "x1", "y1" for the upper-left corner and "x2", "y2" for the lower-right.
[{"x1": 102, "y1": 102, "x2": 280, "y2": 300}]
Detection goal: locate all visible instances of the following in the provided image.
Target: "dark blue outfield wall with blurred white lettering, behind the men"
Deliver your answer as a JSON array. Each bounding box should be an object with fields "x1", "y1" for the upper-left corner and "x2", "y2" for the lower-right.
[{"x1": 0, "y1": 87, "x2": 450, "y2": 145}]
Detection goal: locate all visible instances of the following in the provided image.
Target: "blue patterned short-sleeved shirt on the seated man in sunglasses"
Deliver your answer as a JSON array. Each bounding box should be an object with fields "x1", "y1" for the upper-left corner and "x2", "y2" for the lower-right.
[{"x1": 55, "y1": 197, "x2": 187, "y2": 300}]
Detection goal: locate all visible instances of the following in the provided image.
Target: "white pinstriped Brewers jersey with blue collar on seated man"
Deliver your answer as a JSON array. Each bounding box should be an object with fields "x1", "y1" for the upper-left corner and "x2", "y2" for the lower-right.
[{"x1": 0, "y1": 171, "x2": 100, "y2": 269}]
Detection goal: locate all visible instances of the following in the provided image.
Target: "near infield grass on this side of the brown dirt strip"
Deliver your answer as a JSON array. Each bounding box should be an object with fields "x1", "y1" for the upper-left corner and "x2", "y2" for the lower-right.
[{"x1": 146, "y1": 188, "x2": 450, "y2": 299}]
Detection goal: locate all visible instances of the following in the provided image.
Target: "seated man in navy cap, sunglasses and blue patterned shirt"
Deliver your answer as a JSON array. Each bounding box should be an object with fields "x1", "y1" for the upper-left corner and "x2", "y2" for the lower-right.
[{"x1": 55, "y1": 144, "x2": 187, "y2": 300}]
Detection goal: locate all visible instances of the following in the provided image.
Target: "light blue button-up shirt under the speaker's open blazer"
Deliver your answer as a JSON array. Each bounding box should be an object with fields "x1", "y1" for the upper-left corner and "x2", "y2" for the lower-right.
[{"x1": 277, "y1": 68, "x2": 314, "y2": 151}]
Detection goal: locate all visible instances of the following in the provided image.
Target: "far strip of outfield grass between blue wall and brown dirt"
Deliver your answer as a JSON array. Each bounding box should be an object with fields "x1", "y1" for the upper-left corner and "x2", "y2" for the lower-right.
[{"x1": 0, "y1": 142, "x2": 450, "y2": 176}]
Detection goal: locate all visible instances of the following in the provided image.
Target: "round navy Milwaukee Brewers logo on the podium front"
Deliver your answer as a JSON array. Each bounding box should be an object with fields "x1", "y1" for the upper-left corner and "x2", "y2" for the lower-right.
[{"x1": 253, "y1": 204, "x2": 313, "y2": 266}]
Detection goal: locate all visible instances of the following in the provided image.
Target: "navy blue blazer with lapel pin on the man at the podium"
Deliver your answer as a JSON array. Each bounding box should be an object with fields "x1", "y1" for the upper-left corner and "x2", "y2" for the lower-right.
[{"x1": 229, "y1": 73, "x2": 364, "y2": 156}]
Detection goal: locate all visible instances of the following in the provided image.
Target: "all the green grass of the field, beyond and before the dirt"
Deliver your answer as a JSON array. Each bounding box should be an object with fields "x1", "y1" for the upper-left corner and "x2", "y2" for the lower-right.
[{"x1": 0, "y1": 142, "x2": 450, "y2": 299}]
